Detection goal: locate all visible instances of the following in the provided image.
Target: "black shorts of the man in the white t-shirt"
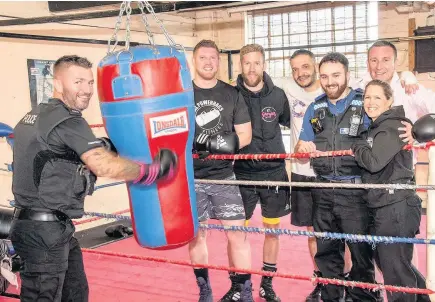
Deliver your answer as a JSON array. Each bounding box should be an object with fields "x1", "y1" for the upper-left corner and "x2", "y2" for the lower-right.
[{"x1": 291, "y1": 173, "x2": 316, "y2": 226}]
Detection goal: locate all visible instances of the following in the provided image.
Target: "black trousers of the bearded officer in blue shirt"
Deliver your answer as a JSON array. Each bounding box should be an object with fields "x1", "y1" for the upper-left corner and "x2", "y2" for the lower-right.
[{"x1": 311, "y1": 189, "x2": 379, "y2": 302}]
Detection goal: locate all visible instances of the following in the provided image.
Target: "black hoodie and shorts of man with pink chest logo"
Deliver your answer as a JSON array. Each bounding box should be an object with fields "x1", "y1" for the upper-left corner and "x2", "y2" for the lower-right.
[{"x1": 234, "y1": 72, "x2": 290, "y2": 219}]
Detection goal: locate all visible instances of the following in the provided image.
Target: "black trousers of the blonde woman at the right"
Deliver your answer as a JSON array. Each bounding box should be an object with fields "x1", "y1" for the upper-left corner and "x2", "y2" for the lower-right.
[{"x1": 370, "y1": 196, "x2": 430, "y2": 302}]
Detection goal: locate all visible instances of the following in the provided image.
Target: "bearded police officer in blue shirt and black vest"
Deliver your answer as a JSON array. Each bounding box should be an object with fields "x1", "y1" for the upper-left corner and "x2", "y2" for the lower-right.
[{"x1": 295, "y1": 53, "x2": 378, "y2": 301}]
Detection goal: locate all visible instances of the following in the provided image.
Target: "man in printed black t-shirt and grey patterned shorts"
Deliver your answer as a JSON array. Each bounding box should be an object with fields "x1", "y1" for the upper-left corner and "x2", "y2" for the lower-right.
[{"x1": 189, "y1": 40, "x2": 253, "y2": 302}]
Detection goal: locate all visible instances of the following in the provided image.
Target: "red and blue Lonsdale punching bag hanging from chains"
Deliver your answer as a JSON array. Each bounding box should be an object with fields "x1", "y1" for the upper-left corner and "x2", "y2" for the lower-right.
[{"x1": 98, "y1": 46, "x2": 198, "y2": 249}]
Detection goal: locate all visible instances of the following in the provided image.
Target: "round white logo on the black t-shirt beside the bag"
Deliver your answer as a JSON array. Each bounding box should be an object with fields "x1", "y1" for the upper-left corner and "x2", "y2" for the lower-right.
[{"x1": 195, "y1": 100, "x2": 224, "y2": 135}]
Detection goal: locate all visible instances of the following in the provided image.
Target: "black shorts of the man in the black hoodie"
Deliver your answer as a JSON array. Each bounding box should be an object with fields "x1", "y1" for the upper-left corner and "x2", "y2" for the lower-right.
[{"x1": 236, "y1": 168, "x2": 291, "y2": 220}]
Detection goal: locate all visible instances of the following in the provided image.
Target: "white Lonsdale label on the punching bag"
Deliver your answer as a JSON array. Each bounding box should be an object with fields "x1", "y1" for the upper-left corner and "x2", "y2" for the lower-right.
[{"x1": 150, "y1": 111, "x2": 189, "y2": 138}]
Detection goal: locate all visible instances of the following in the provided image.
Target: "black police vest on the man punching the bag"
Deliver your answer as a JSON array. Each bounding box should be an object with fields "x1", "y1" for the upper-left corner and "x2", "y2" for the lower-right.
[{"x1": 12, "y1": 99, "x2": 96, "y2": 218}]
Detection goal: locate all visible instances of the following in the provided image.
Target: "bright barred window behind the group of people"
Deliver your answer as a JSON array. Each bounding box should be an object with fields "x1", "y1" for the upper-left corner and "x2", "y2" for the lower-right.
[{"x1": 246, "y1": 1, "x2": 378, "y2": 78}]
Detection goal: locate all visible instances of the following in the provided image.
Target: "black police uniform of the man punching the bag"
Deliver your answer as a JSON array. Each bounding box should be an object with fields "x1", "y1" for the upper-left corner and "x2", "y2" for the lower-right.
[{"x1": 10, "y1": 99, "x2": 103, "y2": 302}]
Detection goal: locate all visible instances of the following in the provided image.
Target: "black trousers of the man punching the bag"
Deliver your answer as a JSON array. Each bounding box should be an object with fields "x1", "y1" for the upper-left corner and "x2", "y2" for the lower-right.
[{"x1": 10, "y1": 220, "x2": 89, "y2": 302}]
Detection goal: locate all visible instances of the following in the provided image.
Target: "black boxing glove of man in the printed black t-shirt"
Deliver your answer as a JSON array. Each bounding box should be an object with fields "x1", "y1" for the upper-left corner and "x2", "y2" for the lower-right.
[{"x1": 195, "y1": 132, "x2": 239, "y2": 154}]
